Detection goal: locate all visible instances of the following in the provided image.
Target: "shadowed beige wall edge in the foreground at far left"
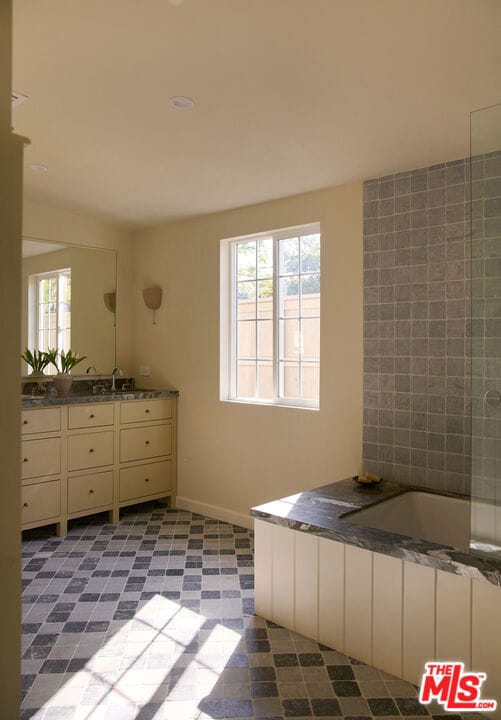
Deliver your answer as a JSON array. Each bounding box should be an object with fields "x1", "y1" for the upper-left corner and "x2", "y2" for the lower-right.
[{"x1": 0, "y1": 0, "x2": 22, "y2": 720}]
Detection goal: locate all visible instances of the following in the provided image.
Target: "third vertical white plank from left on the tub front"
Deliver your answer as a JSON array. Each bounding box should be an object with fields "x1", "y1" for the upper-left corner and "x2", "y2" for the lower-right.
[{"x1": 294, "y1": 532, "x2": 318, "y2": 639}]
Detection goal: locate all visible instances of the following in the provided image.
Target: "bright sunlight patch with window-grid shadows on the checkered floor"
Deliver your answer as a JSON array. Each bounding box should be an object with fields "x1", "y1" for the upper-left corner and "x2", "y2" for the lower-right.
[{"x1": 33, "y1": 595, "x2": 241, "y2": 720}]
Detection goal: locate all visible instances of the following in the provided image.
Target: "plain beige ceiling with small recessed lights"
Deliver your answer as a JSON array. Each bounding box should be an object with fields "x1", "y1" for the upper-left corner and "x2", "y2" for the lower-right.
[{"x1": 13, "y1": 0, "x2": 501, "y2": 228}]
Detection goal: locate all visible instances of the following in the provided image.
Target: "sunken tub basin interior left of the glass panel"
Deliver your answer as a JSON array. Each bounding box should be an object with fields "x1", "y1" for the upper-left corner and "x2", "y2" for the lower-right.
[{"x1": 343, "y1": 490, "x2": 470, "y2": 550}]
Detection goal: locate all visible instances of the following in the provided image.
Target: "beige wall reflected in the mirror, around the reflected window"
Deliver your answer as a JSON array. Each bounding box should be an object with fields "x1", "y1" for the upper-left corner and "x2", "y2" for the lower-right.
[{"x1": 21, "y1": 247, "x2": 117, "y2": 374}]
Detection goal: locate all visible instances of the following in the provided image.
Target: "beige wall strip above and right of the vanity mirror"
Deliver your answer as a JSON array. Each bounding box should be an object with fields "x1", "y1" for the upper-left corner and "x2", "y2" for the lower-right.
[{"x1": 23, "y1": 202, "x2": 133, "y2": 374}]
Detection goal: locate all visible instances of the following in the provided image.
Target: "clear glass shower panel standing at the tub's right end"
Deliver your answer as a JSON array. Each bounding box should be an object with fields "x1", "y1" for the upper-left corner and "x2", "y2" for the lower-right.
[{"x1": 471, "y1": 105, "x2": 501, "y2": 557}]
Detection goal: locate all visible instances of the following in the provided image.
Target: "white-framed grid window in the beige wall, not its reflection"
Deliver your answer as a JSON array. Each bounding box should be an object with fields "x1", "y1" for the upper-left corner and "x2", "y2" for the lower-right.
[{"x1": 221, "y1": 223, "x2": 320, "y2": 407}]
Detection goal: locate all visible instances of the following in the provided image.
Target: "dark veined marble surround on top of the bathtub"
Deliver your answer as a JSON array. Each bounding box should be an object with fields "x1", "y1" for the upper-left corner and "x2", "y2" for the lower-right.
[{"x1": 251, "y1": 478, "x2": 501, "y2": 585}]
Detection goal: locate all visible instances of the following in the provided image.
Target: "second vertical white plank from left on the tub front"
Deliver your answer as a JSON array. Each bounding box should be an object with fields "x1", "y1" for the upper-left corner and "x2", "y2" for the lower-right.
[{"x1": 272, "y1": 525, "x2": 296, "y2": 630}]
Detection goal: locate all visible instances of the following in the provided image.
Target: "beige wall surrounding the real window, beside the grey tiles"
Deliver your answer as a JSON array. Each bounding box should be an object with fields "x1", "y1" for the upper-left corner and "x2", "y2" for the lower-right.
[{"x1": 134, "y1": 183, "x2": 362, "y2": 522}]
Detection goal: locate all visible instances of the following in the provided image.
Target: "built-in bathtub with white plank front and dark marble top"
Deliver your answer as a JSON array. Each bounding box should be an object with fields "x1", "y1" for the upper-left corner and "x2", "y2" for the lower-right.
[{"x1": 253, "y1": 481, "x2": 501, "y2": 720}]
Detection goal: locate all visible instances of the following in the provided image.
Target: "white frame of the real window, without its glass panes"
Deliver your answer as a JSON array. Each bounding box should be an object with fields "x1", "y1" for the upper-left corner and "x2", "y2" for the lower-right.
[{"x1": 220, "y1": 222, "x2": 322, "y2": 410}]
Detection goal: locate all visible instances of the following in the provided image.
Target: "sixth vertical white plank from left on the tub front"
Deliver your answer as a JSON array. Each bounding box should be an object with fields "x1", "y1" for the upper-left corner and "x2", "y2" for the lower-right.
[{"x1": 372, "y1": 553, "x2": 403, "y2": 677}]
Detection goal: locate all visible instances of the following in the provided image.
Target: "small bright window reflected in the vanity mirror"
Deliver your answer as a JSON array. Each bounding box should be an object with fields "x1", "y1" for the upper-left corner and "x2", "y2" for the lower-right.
[{"x1": 29, "y1": 269, "x2": 71, "y2": 373}]
